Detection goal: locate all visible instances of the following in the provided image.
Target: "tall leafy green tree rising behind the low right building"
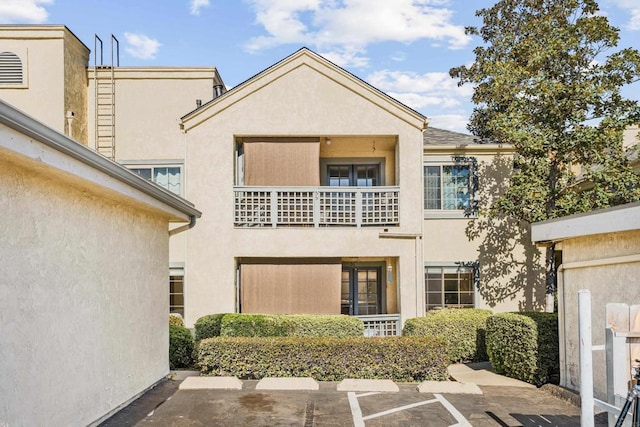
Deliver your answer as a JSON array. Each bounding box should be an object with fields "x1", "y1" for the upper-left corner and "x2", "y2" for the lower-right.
[{"x1": 450, "y1": 0, "x2": 640, "y2": 311}]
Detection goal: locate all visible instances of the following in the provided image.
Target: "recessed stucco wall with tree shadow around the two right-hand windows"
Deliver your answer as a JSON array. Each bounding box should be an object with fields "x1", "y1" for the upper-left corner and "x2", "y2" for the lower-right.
[{"x1": 424, "y1": 150, "x2": 545, "y2": 312}]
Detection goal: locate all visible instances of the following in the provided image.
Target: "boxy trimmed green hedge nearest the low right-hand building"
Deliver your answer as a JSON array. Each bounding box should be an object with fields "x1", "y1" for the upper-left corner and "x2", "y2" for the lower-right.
[{"x1": 487, "y1": 312, "x2": 560, "y2": 386}]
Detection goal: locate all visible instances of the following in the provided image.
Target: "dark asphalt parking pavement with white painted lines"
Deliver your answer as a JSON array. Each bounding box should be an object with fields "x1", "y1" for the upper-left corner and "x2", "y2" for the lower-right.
[{"x1": 103, "y1": 381, "x2": 606, "y2": 427}]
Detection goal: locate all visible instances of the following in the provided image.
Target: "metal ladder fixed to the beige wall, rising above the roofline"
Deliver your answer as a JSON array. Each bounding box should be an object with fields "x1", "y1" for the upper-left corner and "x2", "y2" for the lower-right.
[{"x1": 93, "y1": 34, "x2": 120, "y2": 160}]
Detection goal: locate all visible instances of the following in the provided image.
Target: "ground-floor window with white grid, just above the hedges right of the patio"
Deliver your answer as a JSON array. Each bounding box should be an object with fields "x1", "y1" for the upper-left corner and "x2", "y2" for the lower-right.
[{"x1": 425, "y1": 266, "x2": 474, "y2": 310}]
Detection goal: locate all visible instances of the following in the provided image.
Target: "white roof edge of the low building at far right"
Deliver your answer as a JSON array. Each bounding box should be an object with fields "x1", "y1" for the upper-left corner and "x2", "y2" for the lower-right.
[{"x1": 531, "y1": 202, "x2": 640, "y2": 243}]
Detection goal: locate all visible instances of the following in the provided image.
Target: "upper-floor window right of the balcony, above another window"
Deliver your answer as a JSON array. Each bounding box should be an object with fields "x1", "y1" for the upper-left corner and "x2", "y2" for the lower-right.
[{"x1": 424, "y1": 164, "x2": 472, "y2": 211}]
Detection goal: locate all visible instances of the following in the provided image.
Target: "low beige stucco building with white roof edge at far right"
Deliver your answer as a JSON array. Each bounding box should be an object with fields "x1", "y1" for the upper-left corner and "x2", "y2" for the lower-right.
[{"x1": 532, "y1": 202, "x2": 640, "y2": 401}]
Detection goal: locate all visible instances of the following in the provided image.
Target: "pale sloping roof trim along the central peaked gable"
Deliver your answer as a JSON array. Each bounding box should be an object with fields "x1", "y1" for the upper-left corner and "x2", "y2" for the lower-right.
[{"x1": 180, "y1": 47, "x2": 427, "y2": 132}]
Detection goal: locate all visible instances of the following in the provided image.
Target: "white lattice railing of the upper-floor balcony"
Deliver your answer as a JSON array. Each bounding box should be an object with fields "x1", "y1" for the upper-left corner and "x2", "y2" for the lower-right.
[{"x1": 233, "y1": 187, "x2": 400, "y2": 227}]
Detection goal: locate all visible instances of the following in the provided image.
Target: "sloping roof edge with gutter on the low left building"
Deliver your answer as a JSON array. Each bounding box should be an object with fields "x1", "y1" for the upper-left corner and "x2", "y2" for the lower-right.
[{"x1": 0, "y1": 100, "x2": 201, "y2": 218}]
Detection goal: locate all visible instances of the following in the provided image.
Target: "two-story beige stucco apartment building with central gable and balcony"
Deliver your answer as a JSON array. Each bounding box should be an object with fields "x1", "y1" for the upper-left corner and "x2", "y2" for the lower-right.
[{"x1": 0, "y1": 26, "x2": 543, "y2": 334}]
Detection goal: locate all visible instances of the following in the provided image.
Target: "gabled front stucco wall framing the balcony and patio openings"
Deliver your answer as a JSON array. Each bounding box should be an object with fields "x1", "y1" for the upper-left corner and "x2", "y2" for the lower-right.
[{"x1": 180, "y1": 60, "x2": 423, "y2": 323}]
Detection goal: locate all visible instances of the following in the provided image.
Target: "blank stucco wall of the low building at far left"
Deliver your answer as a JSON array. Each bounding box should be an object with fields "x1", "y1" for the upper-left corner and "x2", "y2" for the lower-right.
[{"x1": 0, "y1": 153, "x2": 168, "y2": 427}]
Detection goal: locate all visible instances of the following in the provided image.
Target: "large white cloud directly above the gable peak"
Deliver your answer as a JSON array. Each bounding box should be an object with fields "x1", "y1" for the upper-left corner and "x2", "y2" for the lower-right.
[{"x1": 245, "y1": 0, "x2": 471, "y2": 65}]
